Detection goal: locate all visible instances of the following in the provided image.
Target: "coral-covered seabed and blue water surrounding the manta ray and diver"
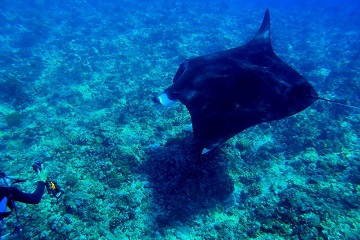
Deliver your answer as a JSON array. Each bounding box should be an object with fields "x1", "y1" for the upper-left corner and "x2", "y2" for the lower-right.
[{"x1": 0, "y1": 0, "x2": 360, "y2": 239}]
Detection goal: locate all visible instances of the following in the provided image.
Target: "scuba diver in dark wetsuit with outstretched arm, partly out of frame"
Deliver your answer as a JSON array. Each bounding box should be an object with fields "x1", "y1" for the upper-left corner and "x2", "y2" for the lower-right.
[{"x1": 0, "y1": 162, "x2": 49, "y2": 239}]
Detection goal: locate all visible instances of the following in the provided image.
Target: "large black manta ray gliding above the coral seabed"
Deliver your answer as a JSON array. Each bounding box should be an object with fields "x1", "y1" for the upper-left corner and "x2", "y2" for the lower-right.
[{"x1": 153, "y1": 10, "x2": 320, "y2": 154}]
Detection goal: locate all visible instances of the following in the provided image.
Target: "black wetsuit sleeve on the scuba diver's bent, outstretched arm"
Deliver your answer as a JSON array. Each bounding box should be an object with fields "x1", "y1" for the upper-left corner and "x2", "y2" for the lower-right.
[{"x1": 0, "y1": 181, "x2": 45, "y2": 207}]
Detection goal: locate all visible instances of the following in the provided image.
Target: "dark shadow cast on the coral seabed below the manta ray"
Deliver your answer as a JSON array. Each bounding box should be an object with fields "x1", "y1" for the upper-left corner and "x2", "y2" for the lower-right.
[{"x1": 141, "y1": 134, "x2": 234, "y2": 228}]
